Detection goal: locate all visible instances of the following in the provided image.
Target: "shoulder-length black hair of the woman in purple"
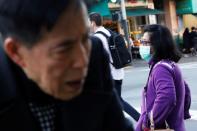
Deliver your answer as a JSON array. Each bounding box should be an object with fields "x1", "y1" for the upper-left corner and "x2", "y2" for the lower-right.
[{"x1": 144, "y1": 24, "x2": 181, "y2": 62}]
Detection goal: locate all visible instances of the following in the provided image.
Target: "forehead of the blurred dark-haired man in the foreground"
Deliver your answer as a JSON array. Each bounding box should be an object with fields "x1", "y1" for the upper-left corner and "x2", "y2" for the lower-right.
[{"x1": 38, "y1": 0, "x2": 89, "y2": 39}]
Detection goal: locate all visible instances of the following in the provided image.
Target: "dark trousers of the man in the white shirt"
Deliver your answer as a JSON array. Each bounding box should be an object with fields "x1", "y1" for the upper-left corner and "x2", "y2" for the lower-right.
[{"x1": 114, "y1": 80, "x2": 140, "y2": 121}]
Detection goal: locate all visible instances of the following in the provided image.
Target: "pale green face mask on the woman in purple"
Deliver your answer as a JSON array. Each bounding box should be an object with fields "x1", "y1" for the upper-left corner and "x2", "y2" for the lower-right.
[{"x1": 139, "y1": 45, "x2": 151, "y2": 62}]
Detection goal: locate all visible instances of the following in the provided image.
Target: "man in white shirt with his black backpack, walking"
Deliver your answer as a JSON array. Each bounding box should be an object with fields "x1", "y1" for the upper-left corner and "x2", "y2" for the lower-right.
[{"x1": 89, "y1": 12, "x2": 140, "y2": 121}]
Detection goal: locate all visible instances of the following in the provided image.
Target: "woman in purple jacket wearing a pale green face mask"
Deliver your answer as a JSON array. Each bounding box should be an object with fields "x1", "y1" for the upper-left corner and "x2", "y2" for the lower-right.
[{"x1": 136, "y1": 25, "x2": 191, "y2": 131}]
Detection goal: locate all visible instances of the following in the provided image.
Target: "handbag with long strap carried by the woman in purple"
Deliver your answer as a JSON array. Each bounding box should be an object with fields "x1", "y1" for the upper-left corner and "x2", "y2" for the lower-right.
[{"x1": 144, "y1": 62, "x2": 174, "y2": 131}]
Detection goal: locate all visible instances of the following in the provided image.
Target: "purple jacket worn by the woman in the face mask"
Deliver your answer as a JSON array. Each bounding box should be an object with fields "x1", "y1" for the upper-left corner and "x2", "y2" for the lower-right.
[{"x1": 136, "y1": 60, "x2": 191, "y2": 131}]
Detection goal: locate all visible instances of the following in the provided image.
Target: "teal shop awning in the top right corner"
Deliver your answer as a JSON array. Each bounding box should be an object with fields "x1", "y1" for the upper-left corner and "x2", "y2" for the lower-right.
[{"x1": 176, "y1": 0, "x2": 197, "y2": 14}]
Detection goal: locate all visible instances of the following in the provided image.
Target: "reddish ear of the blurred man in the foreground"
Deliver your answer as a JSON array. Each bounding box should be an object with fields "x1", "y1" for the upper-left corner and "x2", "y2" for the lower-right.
[{"x1": 3, "y1": 37, "x2": 25, "y2": 67}]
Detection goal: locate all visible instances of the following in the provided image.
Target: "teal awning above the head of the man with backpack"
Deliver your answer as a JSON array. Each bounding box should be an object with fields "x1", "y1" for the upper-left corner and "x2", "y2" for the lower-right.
[{"x1": 88, "y1": 1, "x2": 111, "y2": 17}]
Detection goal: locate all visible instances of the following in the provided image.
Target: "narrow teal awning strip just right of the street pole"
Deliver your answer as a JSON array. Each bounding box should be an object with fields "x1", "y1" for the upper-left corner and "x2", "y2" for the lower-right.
[{"x1": 126, "y1": 8, "x2": 164, "y2": 16}]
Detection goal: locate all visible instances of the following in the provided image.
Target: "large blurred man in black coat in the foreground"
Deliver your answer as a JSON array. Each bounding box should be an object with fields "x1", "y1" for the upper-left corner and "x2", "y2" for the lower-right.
[{"x1": 0, "y1": 0, "x2": 133, "y2": 131}]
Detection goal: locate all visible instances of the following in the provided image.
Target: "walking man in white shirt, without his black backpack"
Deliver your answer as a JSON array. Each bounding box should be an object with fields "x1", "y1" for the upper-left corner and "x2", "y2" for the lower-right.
[{"x1": 89, "y1": 12, "x2": 140, "y2": 121}]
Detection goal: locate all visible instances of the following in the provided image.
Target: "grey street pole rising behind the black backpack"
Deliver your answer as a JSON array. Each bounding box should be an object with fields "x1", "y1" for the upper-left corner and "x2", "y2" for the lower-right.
[{"x1": 120, "y1": 0, "x2": 132, "y2": 57}]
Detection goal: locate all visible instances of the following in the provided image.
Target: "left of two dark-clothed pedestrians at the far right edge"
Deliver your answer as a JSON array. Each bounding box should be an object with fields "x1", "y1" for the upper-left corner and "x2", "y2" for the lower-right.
[{"x1": 183, "y1": 28, "x2": 191, "y2": 53}]
